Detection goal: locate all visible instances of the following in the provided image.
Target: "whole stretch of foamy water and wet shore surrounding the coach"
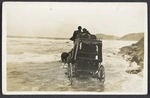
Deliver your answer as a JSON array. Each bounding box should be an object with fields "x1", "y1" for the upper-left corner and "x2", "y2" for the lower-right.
[{"x1": 6, "y1": 37, "x2": 144, "y2": 93}]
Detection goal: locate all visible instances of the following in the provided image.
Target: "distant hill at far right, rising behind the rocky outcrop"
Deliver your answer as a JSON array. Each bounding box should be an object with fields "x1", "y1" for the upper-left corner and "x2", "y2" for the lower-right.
[{"x1": 119, "y1": 33, "x2": 144, "y2": 41}]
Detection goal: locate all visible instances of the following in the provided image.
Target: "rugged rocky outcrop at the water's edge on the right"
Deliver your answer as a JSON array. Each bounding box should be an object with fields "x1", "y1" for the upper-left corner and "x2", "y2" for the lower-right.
[{"x1": 119, "y1": 37, "x2": 144, "y2": 73}]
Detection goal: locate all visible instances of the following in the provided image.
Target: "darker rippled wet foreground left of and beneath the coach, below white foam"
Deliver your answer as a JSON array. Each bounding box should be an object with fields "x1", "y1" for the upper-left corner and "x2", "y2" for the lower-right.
[{"x1": 7, "y1": 61, "x2": 102, "y2": 91}]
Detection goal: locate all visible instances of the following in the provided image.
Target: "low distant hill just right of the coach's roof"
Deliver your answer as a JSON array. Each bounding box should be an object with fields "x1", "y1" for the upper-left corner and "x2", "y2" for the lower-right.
[{"x1": 96, "y1": 33, "x2": 119, "y2": 40}]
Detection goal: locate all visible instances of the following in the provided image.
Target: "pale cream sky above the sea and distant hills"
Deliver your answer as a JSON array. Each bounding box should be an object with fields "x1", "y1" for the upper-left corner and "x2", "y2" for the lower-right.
[{"x1": 3, "y1": 2, "x2": 147, "y2": 38}]
